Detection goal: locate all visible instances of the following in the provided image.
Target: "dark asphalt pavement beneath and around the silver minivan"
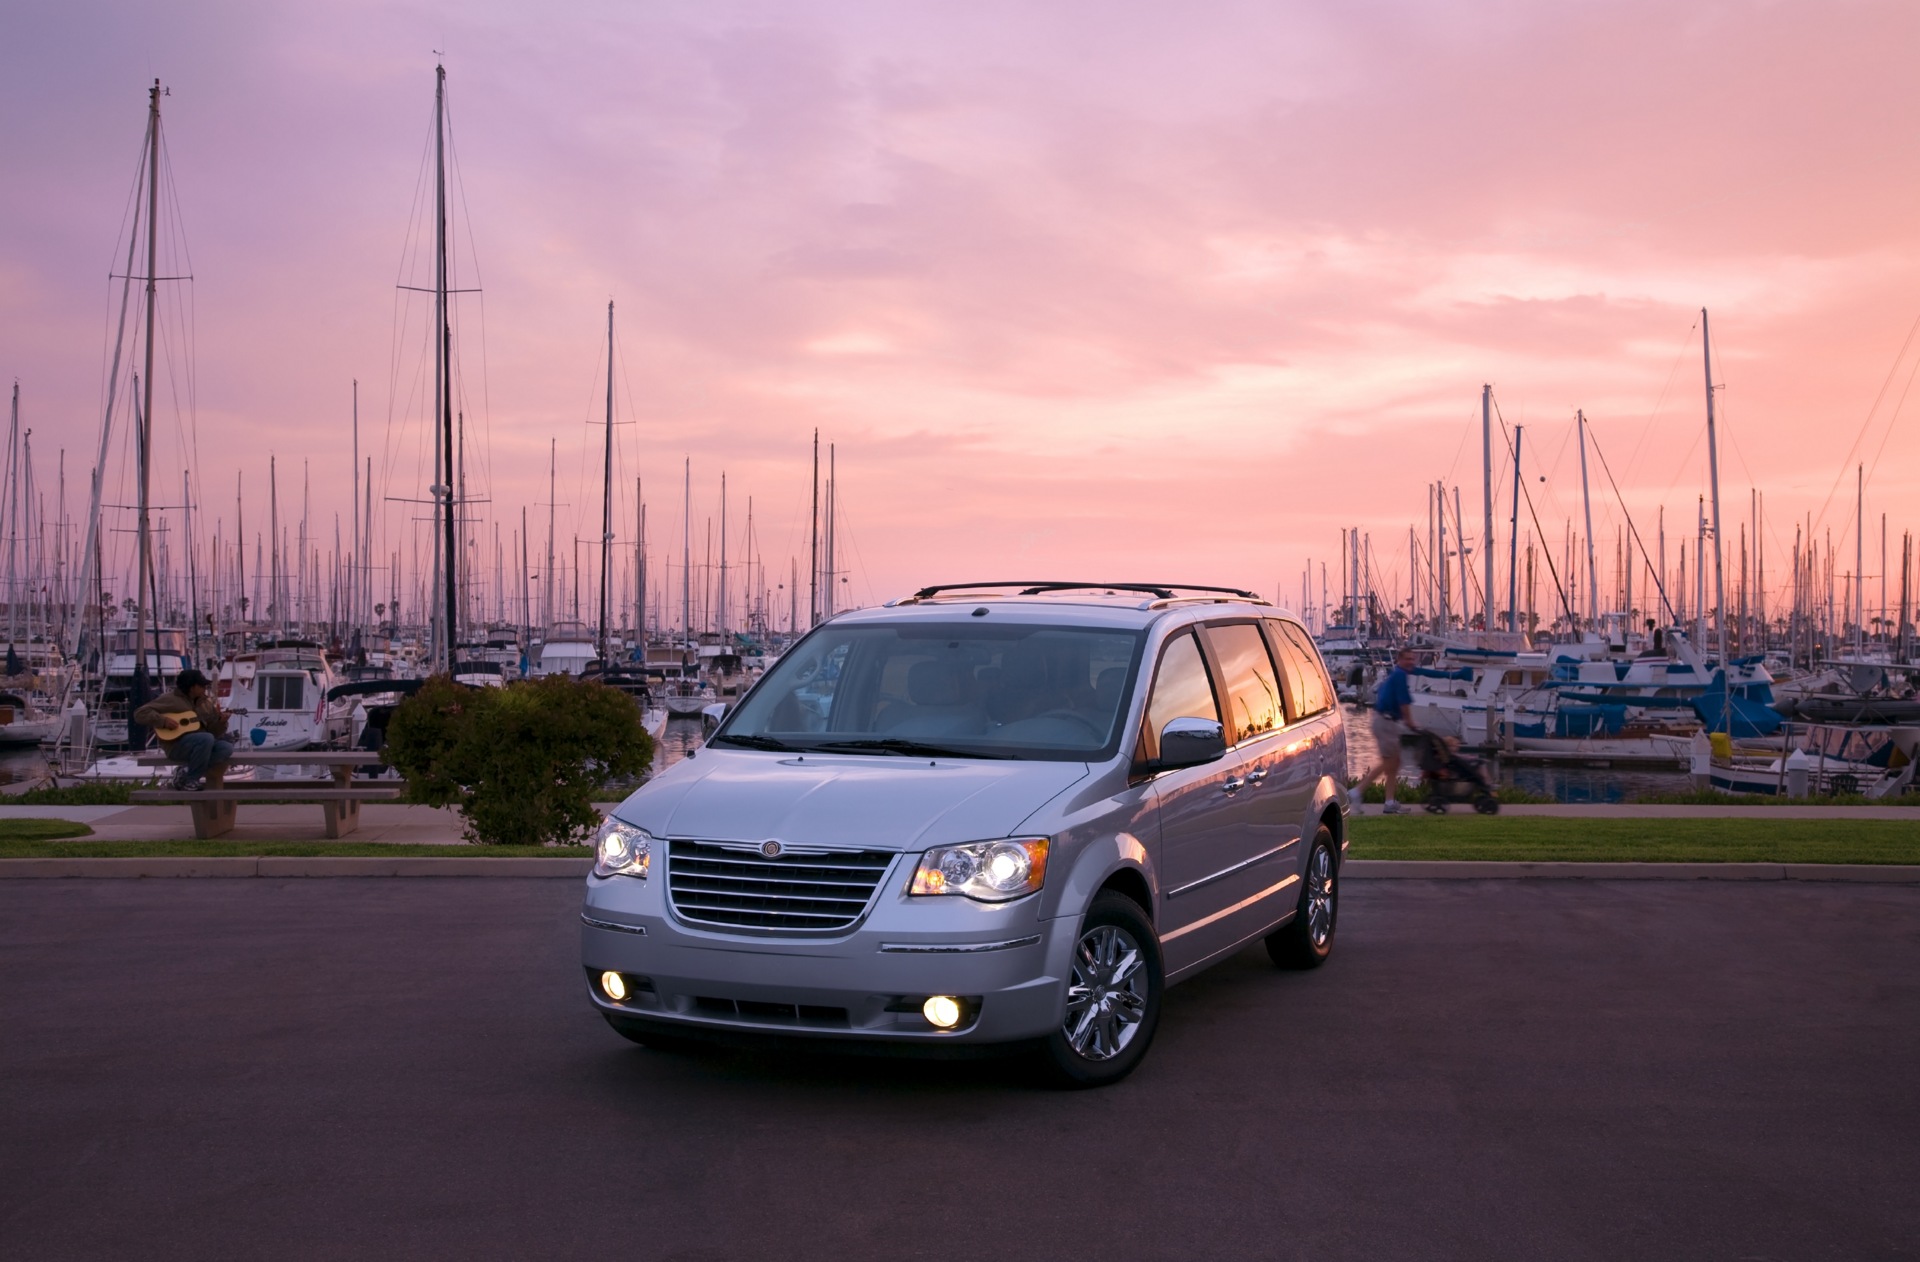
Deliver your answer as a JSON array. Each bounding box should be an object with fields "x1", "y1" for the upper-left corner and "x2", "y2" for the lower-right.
[{"x1": 0, "y1": 878, "x2": 1920, "y2": 1262}]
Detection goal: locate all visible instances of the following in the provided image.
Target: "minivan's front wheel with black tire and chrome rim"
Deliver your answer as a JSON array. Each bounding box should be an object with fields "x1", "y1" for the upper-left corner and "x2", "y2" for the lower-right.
[{"x1": 1041, "y1": 889, "x2": 1167, "y2": 1087}]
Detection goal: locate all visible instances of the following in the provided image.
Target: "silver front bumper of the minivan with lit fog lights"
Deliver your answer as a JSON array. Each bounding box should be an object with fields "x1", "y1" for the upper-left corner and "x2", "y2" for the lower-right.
[{"x1": 580, "y1": 857, "x2": 1077, "y2": 1045}]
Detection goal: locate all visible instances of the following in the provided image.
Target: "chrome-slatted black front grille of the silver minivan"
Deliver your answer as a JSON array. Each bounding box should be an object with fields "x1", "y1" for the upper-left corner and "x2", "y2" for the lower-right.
[{"x1": 666, "y1": 841, "x2": 893, "y2": 932}]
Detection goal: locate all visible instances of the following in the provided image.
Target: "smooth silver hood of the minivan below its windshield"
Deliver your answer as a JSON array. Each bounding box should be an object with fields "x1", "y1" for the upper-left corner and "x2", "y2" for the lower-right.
[{"x1": 616, "y1": 747, "x2": 1089, "y2": 851}]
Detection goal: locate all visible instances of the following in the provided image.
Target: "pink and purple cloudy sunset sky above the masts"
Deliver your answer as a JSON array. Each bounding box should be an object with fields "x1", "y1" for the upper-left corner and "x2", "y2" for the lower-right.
[{"x1": 0, "y1": 0, "x2": 1920, "y2": 630}]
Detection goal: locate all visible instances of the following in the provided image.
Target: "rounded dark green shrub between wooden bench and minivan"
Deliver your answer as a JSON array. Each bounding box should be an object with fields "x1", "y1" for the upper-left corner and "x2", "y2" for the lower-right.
[{"x1": 386, "y1": 676, "x2": 653, "y2": 845}]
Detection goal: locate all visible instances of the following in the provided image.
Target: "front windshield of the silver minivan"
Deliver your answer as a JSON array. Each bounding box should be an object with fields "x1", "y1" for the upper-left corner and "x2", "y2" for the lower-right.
[{"x1": 712, "y1": 620, "x2": 1142, "y2": 761}]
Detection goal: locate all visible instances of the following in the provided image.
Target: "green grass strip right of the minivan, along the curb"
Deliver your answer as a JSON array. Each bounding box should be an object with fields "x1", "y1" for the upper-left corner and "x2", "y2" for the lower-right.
[{"x1": 1348, "y1": 813, "x2": 1920, "y2": 862}]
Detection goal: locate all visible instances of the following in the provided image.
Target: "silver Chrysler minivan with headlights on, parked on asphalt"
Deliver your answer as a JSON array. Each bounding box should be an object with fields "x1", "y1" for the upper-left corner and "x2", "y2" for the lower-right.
[{"x1": 580, "y1": 582, "x2": 1346, "y2": 1085}]
